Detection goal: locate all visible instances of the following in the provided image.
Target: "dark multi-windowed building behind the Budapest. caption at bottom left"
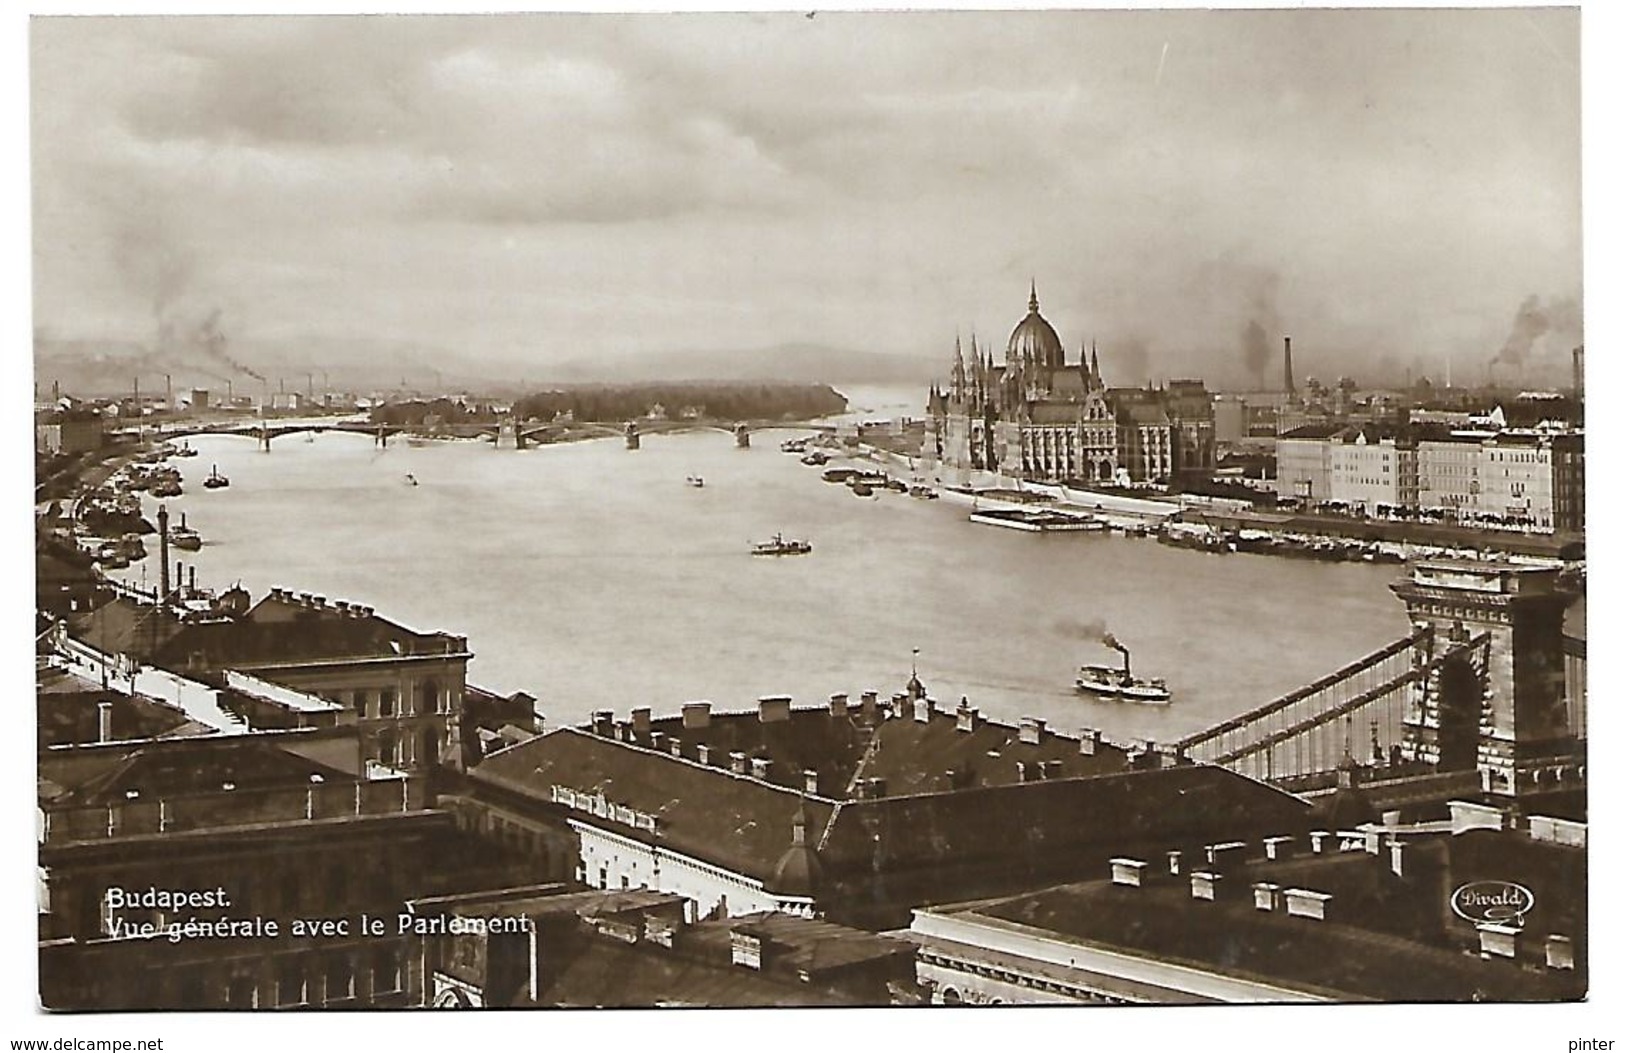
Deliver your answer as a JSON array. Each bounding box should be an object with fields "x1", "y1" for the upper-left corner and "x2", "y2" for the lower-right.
[{"x1": 37, "y1": 731, "x2": 525, "y2": 1011}]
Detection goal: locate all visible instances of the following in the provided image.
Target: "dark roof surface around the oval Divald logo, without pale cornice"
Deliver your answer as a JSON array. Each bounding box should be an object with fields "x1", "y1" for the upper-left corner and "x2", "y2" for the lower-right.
[{"x1": 943, "y1": 830, "x2": 1584, "y2": 1001}]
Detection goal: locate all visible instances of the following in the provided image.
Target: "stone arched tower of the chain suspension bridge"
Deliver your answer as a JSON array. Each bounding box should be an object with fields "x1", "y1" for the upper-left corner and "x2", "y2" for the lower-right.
[{"x1": 1391, "y1": 561, "x2": 1581, "y2": 796}]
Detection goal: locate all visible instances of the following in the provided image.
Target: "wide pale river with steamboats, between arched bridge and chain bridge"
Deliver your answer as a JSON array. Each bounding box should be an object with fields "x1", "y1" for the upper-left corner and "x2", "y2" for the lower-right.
[{"x1": 114, "y1": 419, "x2": 1560, "y2": 741}]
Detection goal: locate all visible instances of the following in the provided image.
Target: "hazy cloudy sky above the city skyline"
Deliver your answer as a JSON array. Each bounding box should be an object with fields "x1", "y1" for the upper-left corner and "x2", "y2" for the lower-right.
[{"x1": 31, "y1": 10, "x2": 1581, "y2": 384}]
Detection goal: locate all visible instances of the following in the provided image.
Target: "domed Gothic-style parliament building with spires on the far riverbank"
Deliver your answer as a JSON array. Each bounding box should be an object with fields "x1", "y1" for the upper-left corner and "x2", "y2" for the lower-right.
[{"x1": 921, "y1": 286, "x2": 1214, "y2": 486}]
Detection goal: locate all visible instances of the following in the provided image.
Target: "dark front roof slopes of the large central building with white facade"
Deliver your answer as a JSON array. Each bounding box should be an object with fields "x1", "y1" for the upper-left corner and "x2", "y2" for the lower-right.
[{"x1": 473, "y1": 722, "x2": 1308, "y2": 889}]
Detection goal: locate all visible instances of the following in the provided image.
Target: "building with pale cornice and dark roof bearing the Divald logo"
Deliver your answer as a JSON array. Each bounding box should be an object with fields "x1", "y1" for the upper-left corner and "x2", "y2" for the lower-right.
[{"x1": 908, "y1": 801, "x2": 1588, "y2": 1004}]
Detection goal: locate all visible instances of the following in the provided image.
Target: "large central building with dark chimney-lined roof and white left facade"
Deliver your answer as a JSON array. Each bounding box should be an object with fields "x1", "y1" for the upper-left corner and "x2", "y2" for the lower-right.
[{"x1": 457, "y1": 689, "x2": 1307, "y2": 928}]
